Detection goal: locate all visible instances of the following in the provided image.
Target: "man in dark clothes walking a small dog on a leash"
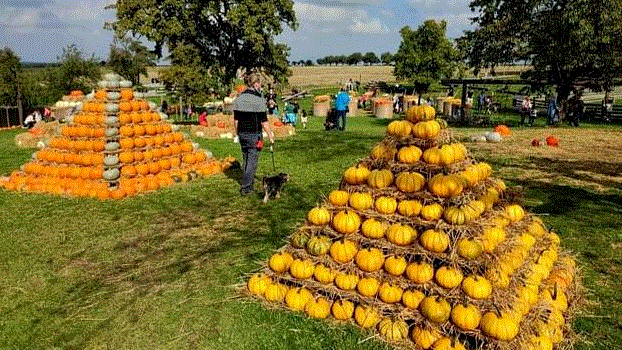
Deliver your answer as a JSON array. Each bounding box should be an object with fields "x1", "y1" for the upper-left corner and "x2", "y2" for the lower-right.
[{"x1": 233, "y1": 74, "x2": 274, "y2": 196}]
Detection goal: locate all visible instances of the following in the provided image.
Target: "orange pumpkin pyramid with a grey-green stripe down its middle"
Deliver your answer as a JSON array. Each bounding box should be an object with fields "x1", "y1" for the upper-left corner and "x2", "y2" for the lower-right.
[{"x1": 2, "y1": 73, "x2": 232, "y2": 199}]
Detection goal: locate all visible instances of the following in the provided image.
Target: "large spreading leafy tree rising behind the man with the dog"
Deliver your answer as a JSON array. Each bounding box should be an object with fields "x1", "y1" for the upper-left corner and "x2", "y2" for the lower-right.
[{"x1": 110, "y1": 0, "x2": 297, "y2": 94}]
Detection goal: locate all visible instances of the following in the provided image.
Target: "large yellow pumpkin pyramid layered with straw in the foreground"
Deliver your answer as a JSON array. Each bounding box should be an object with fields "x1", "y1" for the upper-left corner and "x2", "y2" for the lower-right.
[{"x1": 244, "y1": 106, "x2": 581, "y2": 350}]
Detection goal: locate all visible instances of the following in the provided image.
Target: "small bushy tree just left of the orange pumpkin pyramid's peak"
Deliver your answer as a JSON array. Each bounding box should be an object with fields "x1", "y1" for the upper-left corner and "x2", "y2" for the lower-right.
[{"x1": 50, "y1": 44, "x2": 101, "y2": 98}]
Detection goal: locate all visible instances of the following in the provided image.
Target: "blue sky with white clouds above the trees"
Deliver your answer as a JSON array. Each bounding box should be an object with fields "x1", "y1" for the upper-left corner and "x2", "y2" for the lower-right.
[{"x1": 0, "y1": 0, "x2": 473, "y2": 62}]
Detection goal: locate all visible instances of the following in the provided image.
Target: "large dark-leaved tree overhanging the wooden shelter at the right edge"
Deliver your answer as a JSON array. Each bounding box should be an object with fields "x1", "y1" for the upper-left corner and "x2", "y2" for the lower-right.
[{"x1": 459, "y1": 0, "x2": 622, "y2": 99}]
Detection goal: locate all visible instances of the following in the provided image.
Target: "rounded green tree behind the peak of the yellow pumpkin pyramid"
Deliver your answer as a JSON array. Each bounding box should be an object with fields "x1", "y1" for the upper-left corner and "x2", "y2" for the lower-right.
[{"x1": 394, "y1": 20, "x2": 458, "y2": 98}]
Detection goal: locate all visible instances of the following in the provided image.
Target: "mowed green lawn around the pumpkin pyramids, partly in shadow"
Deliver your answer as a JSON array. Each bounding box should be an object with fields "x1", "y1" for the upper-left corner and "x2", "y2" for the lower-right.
[{"x1": 0, "y1": 110, "x2": 622, "y2": 350}]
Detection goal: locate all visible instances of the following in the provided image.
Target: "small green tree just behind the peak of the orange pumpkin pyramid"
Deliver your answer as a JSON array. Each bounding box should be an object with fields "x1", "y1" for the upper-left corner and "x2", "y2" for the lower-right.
[{"x1": 106, "y1": 39, "x2": 156, "y2": 85}]
